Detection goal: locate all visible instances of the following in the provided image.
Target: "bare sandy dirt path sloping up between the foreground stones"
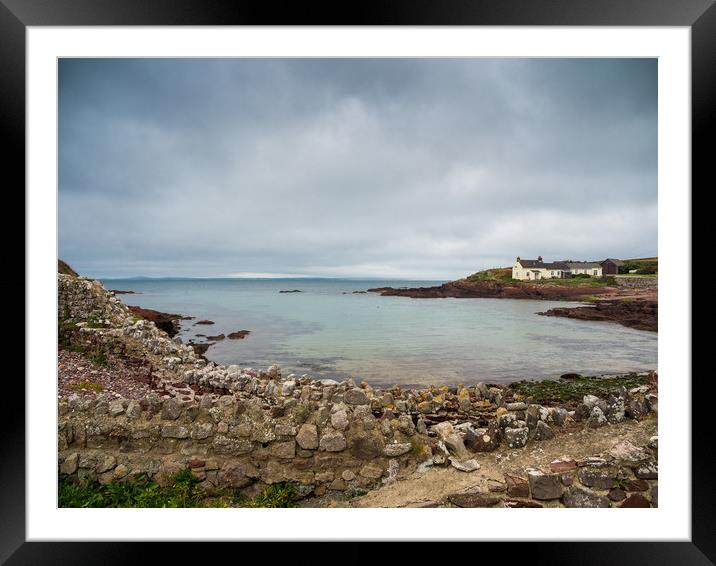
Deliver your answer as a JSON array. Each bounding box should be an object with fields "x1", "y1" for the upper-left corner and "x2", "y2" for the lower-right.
[{"x1": 304, "y1": 417, "x2": 657, "y2": 507}]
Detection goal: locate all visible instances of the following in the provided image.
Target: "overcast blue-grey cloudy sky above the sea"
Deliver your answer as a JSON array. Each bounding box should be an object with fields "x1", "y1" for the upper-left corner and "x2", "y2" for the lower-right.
[{"x1": 59, "y1": 59, "x2": 657, "y2": 279}]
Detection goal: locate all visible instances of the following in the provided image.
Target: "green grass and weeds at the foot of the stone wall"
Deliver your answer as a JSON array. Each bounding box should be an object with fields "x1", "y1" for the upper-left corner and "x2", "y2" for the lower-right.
[{"x1": 58, "y1": 468, "x2": 298, "y2": 507}]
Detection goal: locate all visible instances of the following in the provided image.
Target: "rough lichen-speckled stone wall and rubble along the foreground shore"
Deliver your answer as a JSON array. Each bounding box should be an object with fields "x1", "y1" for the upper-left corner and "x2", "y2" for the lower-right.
[{"x1": 58, "y1": 275, "x2": 658, "y2": 507}]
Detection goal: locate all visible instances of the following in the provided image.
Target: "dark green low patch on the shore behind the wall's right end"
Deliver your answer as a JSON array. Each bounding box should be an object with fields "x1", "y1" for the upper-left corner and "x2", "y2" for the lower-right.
[{"x1": 510, "y1": 373, "x2": 649, "y2": 404}]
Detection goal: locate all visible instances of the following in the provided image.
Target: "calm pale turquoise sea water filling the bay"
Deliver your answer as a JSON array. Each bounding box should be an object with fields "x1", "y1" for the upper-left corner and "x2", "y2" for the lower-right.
[{"x1": 103, "y1": 279, "x2": 657, "y2": 386}]
